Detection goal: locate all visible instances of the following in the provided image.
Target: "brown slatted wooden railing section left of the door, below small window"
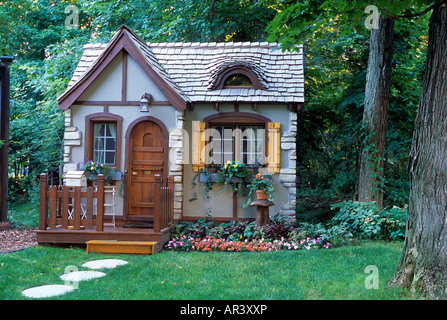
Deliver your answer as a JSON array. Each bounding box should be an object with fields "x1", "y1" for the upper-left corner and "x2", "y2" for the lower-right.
[{"x1": 39, "y1": 174, "x2": 104, "y2": 231}]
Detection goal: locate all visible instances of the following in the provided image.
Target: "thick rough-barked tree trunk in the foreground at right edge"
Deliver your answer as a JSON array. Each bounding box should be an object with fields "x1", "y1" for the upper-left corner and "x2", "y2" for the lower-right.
[{"x1": 391, "y1": 4, "x2": 447, "y2": 299}]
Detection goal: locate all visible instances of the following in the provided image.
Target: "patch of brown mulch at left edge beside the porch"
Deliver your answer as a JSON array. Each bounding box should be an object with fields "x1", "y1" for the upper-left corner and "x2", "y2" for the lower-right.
[{"x1": 0, "y1": 229, "x2": 37, "y2": 253}]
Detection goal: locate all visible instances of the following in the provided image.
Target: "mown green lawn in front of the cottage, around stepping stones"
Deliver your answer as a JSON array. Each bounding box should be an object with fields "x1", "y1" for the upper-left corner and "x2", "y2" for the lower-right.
[{"x1": 0, "y1": 241, "x2": 426, "y2": 300}]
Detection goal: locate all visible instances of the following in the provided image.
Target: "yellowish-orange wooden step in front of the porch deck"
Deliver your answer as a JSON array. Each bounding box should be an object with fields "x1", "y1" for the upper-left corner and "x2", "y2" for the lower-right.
[{"x1": 86, "y1": 240, "x2": 159, "y2": 254}]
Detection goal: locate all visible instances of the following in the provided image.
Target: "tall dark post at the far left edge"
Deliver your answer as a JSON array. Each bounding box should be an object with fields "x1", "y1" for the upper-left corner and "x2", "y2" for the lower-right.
[{"x1": 0, "y1": 57, "x2": 13, "y2": 230}]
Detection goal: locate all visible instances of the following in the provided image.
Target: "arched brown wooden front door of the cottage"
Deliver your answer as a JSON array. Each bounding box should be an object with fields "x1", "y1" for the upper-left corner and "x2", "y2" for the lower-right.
[{"x1": 127, "y1": 120, "x2": 167, "y2": 221}]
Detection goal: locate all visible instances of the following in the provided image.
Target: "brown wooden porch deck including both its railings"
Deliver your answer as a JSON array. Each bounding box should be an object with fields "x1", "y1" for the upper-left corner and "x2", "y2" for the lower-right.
[{"x1": 37, "y1": 174, "x2": 174, "y2": 252}]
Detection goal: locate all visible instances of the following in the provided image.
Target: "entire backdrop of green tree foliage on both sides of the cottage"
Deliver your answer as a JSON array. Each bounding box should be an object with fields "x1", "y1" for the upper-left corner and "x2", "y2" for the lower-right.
[{"x1": 0, "y1": 0, "x2": 427, "y2": 209}]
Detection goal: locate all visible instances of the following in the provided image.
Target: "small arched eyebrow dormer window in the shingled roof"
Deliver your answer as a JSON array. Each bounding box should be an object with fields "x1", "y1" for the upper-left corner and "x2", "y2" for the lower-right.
[{"x1": 212, "y1": 66, "x2": 266, "y2": 90}]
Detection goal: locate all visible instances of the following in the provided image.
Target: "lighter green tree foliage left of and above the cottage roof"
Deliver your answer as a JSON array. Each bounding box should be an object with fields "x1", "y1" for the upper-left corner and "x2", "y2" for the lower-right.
[{"x1": 0, "y1": 0, "x2": 276, "y2": 204}]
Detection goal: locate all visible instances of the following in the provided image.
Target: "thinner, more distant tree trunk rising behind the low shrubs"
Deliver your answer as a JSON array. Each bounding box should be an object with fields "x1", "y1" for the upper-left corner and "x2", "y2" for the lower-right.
[{"x1": 357, "y1": 16, "x2": 394, "y2": 208}]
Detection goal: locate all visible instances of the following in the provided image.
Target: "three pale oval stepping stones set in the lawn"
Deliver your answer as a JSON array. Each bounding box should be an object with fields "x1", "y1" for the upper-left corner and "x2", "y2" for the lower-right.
[{"x1": 22, "y1": 259, "x2": 127, "y2": 299}]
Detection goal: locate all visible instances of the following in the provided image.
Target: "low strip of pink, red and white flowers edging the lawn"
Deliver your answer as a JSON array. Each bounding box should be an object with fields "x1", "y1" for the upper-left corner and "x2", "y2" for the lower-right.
[{"x1": 165, "y1": 235, "x2": 331, "y2": 252}]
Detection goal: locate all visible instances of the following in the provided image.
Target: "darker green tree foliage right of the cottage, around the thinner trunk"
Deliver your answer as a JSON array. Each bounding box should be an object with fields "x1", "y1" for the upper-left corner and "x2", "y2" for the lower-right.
[{"x1": 267, "y1": 0, "x2": 428, "y2": 205}]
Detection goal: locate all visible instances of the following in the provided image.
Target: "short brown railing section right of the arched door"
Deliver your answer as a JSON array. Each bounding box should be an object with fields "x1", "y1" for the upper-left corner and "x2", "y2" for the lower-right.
[{"x1": 154, "y1": 174, "x2": 174, "y2": 232}]
